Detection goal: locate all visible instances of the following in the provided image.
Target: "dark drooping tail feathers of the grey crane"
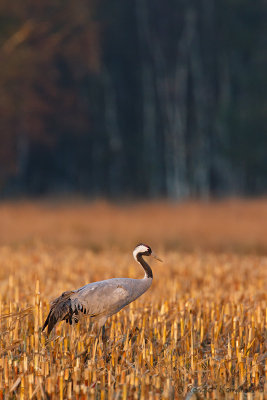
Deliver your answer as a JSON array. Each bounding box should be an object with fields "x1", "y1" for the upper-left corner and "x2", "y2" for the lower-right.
[{"x1": 42, "y1": 291, "x2": 74, "y2": 335}]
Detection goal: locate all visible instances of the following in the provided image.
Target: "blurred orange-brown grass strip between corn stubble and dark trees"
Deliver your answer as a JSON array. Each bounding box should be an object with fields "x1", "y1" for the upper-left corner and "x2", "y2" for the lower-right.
[{"x1": 0, "y1": 199, "x2": 267, "y2": 254}]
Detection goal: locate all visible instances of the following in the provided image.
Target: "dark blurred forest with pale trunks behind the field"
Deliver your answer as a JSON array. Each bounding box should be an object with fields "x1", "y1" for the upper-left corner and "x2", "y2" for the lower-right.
[{"x1": 0, "y1": 0, "x2": 267, "y2": 199}]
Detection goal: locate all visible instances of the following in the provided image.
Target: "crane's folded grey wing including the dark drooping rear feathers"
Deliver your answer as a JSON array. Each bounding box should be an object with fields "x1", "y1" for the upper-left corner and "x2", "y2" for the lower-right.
[{"x1": 42, "y1": 281, "x2": 130, "y2": 335}]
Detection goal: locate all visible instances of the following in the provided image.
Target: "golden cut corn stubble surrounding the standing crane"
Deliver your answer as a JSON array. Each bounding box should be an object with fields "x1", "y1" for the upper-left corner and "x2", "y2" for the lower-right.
[{"x1": 0, "y1": 244, "x2": 267, "y2": 400}]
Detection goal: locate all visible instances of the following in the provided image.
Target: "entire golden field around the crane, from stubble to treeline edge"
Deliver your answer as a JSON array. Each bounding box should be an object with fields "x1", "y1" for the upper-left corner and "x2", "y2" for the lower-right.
[{"x1": 0, "y1": 200, "x2": 267, "y2": 400}]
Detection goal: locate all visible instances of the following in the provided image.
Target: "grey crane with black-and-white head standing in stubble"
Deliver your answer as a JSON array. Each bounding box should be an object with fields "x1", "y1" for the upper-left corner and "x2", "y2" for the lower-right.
[{"x1": 42, "y1": 244, "x2": 162, "y2": 335}]
